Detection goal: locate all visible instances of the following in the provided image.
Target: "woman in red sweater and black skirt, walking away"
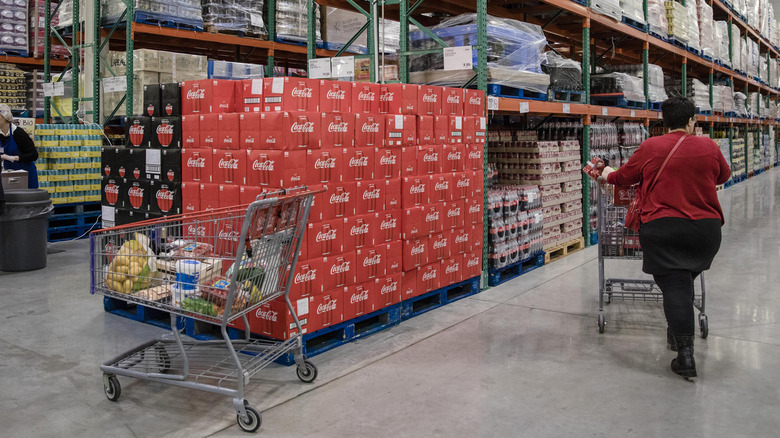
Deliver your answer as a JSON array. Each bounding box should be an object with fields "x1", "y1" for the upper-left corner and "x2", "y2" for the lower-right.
[{"x1": 601, "y1": 98, "x2": 731, "y2": 378}]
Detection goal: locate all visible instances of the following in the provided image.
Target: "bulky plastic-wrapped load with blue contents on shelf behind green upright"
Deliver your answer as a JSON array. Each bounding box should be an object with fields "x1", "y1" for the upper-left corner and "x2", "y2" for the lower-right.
[{"x1": 409, "y1": 14, "x2": 550, "y2": 93}]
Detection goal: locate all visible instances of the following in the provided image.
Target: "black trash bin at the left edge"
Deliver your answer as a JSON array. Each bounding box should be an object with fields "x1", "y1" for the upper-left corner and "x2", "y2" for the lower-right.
[{"x1": 0, "y1": 189, "x2": 52, "y2": 272}]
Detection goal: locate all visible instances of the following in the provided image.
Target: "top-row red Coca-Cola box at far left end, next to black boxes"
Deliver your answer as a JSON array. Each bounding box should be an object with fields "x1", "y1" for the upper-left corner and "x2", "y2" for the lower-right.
[{"x1": 181, "y1": 79, "x2": 236, "y2": 115}]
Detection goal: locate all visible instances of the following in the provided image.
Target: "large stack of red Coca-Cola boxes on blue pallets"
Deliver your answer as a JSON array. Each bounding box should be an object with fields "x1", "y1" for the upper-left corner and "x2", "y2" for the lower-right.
[{"x1": 175, "y1": 77, "x2": 486, "y2": 339}]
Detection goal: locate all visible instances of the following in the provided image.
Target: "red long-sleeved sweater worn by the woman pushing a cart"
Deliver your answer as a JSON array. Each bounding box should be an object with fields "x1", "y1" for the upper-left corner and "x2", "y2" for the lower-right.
[{"x1": 607, "y1": 131, "x2": 731, "y2": 223}]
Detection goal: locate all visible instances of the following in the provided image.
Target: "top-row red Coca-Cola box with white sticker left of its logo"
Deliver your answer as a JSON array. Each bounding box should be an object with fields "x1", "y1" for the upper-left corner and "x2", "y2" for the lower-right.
[{"x1": 263, "y1": 77, "x2": 320, "y2": 112}]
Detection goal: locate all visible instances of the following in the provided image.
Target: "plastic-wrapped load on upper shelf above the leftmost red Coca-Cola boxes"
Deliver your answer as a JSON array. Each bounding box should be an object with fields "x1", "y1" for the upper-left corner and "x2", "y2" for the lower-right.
[{"x1": 201, "y1": 0, "x2": 268, "y2": 38}]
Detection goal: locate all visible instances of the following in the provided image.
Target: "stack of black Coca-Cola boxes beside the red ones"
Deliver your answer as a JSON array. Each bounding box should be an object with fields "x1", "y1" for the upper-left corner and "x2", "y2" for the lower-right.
[{"x1": 102, "y1": 83, "x2": 182, "y2": 227}]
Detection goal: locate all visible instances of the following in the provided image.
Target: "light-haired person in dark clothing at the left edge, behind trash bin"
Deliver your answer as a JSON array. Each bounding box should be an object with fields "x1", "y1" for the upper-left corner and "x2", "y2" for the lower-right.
[{"x1": 0, "y1": 104, "x2": 38, "y2": 189}]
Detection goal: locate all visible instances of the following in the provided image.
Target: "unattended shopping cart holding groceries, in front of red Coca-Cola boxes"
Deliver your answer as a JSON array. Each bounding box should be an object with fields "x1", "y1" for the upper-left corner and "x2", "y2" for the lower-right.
[{"x1": 90, "y1": 188, "x2": 317, "y2": 432}]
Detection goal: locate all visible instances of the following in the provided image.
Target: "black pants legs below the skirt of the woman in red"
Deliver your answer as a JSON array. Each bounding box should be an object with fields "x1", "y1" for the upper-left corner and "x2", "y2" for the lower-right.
[{"x1": 653, "y1": 270, "x2": 701, "y2": 336}]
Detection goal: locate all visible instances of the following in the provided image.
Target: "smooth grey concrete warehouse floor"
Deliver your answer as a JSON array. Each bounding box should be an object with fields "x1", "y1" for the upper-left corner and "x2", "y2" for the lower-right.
[{"x1": 0, "y1": 169, "x2": 780, "y2": 437}]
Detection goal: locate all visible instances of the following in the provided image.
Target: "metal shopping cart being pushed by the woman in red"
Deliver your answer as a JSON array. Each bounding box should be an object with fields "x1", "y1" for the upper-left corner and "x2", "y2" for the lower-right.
[{"x1": 596, "y1": 186, "x2": 709, "y2": 339}]
